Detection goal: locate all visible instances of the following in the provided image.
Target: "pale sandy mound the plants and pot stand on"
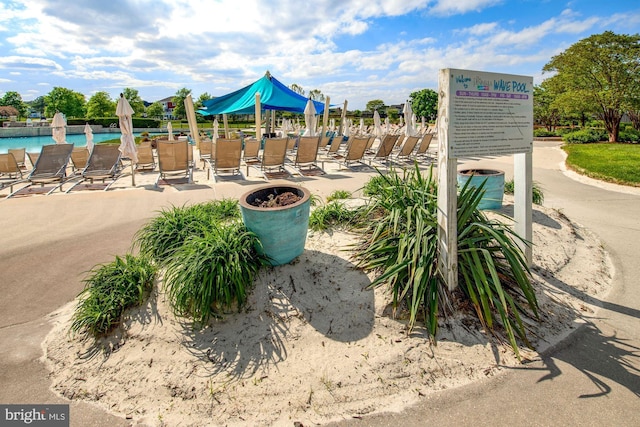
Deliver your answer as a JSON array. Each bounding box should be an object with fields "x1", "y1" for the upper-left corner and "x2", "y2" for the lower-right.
[{"x1": 43, "y1": 191, "x2": 612, "y2": 426}]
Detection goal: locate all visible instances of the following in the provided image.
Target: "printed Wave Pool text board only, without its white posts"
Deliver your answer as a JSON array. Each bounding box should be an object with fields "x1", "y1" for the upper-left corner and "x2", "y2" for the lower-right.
[{"x1": 441, "y1": 69, "x2": 533, "y2": 157}]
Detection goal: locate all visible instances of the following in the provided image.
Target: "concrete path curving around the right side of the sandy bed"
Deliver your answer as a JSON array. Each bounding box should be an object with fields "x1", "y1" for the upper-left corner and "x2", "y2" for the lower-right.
[{"x1": 330, "y1": 142, "x2": 640, "y2": 427}]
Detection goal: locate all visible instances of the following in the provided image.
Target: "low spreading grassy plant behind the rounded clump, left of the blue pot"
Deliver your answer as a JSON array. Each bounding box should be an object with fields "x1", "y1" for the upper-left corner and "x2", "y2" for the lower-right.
[{"x1": 134, "y1": 199, "x2": 240, "y2": 264}]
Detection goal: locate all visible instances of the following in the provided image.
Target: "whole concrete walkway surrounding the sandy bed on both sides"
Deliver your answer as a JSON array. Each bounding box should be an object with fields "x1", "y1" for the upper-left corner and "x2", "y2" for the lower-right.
[{"x1": 0, "y1": 142, "x2": 640, "y2": 427}]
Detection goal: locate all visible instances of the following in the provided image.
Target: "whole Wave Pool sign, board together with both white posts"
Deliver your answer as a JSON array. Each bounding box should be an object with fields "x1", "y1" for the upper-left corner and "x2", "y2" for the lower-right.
[{"x1": 438, "y1": 68, "x2": 533, "y2": 290}]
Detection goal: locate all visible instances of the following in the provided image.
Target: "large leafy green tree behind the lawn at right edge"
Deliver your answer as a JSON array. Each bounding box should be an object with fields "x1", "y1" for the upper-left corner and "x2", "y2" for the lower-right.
[{"x1": 543, "y1": 31, "x2": 640, "y2": 142}]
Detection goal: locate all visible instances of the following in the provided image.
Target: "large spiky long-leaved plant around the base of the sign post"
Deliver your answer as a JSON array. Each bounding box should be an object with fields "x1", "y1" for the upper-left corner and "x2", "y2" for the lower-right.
[{"x1": 355, "y1": 165, "x2": 537, "y2": 357}]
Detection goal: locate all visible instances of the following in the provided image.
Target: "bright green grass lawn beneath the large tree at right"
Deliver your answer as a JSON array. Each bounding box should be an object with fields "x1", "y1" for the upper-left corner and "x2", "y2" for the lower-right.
[{"x1": 562, "y1": 143, "x2": 640, "y2": 187}]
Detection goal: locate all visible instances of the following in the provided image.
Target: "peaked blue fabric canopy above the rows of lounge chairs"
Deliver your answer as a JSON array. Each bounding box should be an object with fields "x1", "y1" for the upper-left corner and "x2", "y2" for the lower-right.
[{"x1": 198, "y1": 71, "x2": 324, "y2": 116}]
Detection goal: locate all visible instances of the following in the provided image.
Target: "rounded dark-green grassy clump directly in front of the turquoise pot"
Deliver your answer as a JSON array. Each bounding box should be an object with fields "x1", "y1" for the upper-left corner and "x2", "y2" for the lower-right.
[{"x1": 165, "y1": 221, "x2": 269, "y2": 323}]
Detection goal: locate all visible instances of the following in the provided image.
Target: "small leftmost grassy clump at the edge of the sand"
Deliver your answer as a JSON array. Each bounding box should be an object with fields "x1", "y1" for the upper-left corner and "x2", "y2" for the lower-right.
[{"x1": 71, "y1": 254, "x2": 156, "y2": 337}]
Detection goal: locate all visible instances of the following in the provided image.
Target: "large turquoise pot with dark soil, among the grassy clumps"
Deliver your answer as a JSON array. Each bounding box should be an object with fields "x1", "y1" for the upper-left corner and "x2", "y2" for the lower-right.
[{"x1": 240, "y1": 185, "x2": 311, "y2": 265}]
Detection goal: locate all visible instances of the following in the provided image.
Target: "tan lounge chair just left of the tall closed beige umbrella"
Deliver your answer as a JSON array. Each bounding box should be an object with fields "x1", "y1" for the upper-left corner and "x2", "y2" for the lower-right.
[{"x1": 66, "y1": 144, "x2": 122, "y2": 193}]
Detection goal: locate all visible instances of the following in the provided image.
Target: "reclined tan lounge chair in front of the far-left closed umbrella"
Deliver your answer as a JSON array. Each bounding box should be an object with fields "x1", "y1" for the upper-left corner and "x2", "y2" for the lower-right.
[{"x1": 7, "y1": 144, "x2": 73, "y2": 198}]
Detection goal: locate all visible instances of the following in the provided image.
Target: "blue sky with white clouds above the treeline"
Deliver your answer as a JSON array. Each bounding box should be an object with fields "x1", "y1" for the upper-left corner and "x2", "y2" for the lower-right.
[{"x1": 0, "y1": 0, "x2": 640, "y2": 110}]
